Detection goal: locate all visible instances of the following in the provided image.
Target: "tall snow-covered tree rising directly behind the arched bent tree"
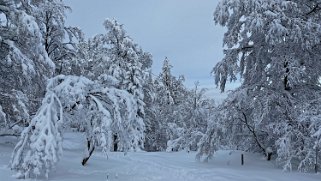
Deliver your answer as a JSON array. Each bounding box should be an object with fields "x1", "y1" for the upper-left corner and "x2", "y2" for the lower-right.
[{"x1": 77, "y1": 19, "x2": 151, "y2": 150}]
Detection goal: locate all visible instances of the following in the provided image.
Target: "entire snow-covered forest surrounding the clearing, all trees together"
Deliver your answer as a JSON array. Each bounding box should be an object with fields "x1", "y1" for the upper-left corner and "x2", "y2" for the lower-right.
[{"x1": 0, "y1": 0, "x2": 321, "y2": 178}]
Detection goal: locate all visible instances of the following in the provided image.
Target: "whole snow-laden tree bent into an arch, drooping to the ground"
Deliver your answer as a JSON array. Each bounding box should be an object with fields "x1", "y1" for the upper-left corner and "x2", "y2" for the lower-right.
[{"x1": 11, "y1": 75, "x2": 145, "y2": 177}]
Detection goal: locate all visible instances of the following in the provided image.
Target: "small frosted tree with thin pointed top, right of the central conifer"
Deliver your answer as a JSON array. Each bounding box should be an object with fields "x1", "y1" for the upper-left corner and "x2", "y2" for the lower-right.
[{"x1": 167, "y1": 82, "x2": 215, "y2": 151}]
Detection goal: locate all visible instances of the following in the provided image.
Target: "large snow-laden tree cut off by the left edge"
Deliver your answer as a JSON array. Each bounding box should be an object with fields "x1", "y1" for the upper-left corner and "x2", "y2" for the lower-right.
[{"x1": 0, "y1": 1, "x2": 55, "y2": 133}]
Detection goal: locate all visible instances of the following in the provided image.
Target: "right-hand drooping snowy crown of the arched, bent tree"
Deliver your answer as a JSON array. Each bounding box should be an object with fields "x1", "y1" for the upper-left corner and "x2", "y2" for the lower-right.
[{"x1": 52, "y1": 76, "x2": 144, "y2": 151}]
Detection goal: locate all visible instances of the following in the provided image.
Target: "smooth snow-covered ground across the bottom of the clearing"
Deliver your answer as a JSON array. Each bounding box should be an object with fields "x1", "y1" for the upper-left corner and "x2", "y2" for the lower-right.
[{"x1": 0, "y1": 134, "x2": 321, "y2": 181}]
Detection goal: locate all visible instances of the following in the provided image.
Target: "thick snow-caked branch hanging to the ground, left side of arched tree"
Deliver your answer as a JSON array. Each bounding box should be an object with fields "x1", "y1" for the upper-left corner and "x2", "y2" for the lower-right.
[{"x1": 11, "y1": 92, "x2": 63, "y2": 178}]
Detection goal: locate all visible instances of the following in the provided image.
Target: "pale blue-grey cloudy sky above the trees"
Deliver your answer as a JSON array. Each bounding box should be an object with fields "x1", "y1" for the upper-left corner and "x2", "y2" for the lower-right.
[{"x1": 65, "y1": 0, "x2": 238, "y2": 100}]
